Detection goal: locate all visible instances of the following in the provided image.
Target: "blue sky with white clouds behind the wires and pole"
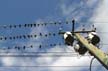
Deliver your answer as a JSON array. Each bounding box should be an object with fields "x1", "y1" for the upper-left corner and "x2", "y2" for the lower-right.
[{"x1": 0, "y1": 0, "x2": 108, "y2": 71}]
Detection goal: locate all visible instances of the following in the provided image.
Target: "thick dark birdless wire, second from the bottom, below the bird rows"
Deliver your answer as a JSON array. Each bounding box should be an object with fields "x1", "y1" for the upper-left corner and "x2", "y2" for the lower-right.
[{"x1": 0, "y1": 53, "x2": 90, "y2": 57}]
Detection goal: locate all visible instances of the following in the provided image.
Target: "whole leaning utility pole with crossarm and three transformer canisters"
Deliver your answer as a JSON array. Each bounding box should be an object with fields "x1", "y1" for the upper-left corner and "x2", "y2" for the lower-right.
[{"x1": 59, "y1": 20, "x2": 108, "y2": 70}]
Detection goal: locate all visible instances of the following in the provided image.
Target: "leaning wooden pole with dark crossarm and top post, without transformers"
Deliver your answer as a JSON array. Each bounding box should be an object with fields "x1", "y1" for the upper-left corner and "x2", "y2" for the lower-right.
[{"x1": 59, "y1": 19, "x2": 108, "y2": 70}]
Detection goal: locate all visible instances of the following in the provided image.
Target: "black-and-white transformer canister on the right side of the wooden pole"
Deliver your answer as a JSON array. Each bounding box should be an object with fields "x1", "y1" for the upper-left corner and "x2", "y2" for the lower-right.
[{"x1": 88, "y1": 32, "x2": 100, "y2": 45}]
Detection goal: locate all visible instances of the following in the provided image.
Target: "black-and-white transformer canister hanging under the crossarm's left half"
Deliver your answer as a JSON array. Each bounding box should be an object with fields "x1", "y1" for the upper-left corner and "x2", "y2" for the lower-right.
[{"x1": 64, "y1": 32, "x2": 74, "y2": 46}]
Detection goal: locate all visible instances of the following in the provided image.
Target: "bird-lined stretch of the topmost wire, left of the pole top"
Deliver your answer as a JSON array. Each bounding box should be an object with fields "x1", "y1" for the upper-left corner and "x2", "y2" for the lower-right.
[{"x1": 0, "y1": 21, "x2": 67, "y2": 29}]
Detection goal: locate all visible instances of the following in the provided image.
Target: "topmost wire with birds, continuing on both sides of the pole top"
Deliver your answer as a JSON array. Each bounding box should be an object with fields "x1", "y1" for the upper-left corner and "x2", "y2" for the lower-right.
[{"x1": 0, "y1": 20, "x2": 108, "y2": 29}]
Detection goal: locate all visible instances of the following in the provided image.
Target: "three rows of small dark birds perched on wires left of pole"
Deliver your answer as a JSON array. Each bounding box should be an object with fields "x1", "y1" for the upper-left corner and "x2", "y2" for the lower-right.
[{"x1": 0, "y1": 21, "x2": 98, "y2": 50}]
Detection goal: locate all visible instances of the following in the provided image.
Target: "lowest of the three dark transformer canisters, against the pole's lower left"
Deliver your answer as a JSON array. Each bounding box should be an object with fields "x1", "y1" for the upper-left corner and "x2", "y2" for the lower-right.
[{"x1": 74, "y1": 41, "x2": 87, "y2": 55}]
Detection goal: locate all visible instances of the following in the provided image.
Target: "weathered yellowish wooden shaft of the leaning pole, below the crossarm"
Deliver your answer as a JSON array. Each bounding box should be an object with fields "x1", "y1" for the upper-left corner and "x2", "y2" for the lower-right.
[{"x1": 74, "y1": 33, "x2": 108, "y2": 70}]
